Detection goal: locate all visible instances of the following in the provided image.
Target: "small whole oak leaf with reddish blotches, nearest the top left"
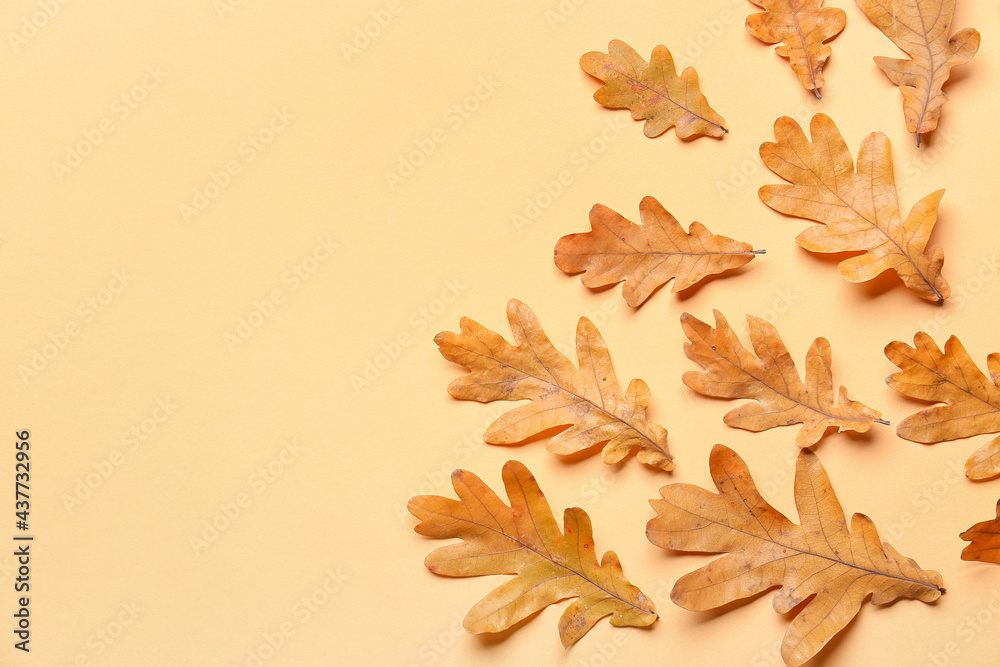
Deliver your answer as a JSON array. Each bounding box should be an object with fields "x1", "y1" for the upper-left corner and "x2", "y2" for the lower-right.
[{"x1": 580, "y1": 39, "x2": 729, "y2": 139}]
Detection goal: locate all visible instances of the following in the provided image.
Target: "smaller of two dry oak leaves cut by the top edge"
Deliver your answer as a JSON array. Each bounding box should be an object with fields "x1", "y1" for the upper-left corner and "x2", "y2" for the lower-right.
[{"x1": 746, "y1": 0, "x2": 847, "y2": 98}]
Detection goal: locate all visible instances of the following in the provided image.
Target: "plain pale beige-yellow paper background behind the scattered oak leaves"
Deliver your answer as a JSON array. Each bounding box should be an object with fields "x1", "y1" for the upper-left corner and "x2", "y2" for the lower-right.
[{"x1": 0, "y1": 0, "x2": 1000, "y2": 667}]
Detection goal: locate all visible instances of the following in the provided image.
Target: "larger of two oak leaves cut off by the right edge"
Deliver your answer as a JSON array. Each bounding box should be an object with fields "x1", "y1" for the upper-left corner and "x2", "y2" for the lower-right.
[{"x1": 885, "y1": 331, "x2": 1000, "y2": 480}]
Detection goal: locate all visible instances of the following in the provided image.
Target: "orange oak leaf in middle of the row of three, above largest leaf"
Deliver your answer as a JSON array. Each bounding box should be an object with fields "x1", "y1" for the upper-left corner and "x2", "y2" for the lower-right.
[{"x1": 681, "y1": 310, "x2": 889, "y2": 447}]
